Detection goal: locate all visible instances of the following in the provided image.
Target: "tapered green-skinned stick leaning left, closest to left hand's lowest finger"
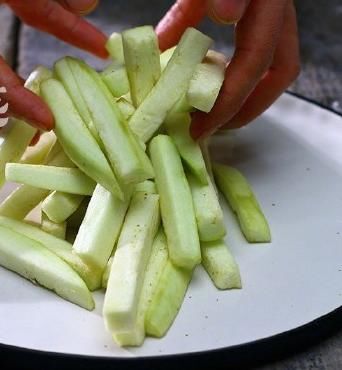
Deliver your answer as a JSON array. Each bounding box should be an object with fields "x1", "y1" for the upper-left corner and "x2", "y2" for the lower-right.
[{"x1": 41, "y1": 79, "x2": 123, "y2": 198}]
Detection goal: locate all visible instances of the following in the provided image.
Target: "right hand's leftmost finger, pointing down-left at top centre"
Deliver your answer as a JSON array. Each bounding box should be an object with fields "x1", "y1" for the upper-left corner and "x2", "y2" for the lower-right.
[{"x1": 156, "y1": 0, "x2": 206, "y2": 50}]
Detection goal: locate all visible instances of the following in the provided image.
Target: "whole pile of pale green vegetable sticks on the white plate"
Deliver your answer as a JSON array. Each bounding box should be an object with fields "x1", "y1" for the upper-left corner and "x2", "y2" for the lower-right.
[{"x1": 0, "y1": 26, "x2": 271, "y2": 346}]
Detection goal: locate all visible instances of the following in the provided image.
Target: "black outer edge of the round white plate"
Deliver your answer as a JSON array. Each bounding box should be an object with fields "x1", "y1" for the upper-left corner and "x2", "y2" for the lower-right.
[{"x1": 0, "y1": 91, "x2": 342, "y2": 370}]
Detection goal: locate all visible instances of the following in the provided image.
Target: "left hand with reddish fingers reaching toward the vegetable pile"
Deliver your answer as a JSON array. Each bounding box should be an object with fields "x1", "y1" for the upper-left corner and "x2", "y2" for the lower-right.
[{"x1": 0, "y1": 0, "x2": 108, "y2": 130}]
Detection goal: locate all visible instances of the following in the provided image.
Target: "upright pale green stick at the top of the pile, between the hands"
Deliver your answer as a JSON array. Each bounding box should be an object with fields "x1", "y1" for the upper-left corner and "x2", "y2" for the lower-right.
[{"x1": 122, "y1": 26, "x2": 160, "y2": 107}]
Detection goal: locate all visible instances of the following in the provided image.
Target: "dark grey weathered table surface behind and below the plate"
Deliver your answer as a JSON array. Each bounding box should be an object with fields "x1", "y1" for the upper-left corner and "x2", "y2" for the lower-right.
[{"x1": 0, "y1": 0, "x2": 342, "y2": 370}]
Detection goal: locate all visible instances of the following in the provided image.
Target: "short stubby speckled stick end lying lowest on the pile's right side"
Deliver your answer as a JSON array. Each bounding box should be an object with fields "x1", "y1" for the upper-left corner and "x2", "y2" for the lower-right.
[{"x1": 201, "y1": 240, "x2": 241, "y2": 289}]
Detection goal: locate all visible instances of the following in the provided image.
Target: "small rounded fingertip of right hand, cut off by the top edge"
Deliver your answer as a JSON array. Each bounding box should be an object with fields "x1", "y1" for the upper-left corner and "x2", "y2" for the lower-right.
[{"x1": 208, "y1": 0, "x2": 250, "y2": 24}]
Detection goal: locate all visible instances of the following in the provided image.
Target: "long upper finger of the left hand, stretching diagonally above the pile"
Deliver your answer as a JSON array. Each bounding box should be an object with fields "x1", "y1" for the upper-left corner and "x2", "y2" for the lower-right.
[{"x1": 7, "y1": 0, "x2": 108, "y2": 58}]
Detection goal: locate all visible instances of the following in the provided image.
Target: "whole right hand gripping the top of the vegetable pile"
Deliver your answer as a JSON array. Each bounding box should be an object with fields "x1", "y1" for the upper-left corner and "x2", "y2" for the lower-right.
[{"x1": 156, "y1": 0, "x2": 300, "y2": 139}]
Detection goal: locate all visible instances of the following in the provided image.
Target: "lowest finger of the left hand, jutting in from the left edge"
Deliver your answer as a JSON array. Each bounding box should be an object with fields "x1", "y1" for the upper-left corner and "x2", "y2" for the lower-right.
[{"x1": 0, "y1": 56, "x2": 54, "y2": 130}]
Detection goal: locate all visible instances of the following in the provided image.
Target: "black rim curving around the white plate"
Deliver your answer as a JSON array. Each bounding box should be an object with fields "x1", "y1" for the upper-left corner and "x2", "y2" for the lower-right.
[{"x1": 0, "y1": 91, "x2": 342, "y2": 370}]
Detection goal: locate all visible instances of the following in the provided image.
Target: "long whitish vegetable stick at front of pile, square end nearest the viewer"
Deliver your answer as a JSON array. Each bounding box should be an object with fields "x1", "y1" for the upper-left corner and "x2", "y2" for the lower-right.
[{"x1": 103, "y1": 192, "x2": 160, "y2": 334}]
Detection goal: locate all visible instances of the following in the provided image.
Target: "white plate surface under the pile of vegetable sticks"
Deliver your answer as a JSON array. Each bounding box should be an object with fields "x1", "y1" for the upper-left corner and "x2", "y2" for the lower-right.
[{"x1": 0, "y1": 94, "x2": 342, "y2": 357}]
